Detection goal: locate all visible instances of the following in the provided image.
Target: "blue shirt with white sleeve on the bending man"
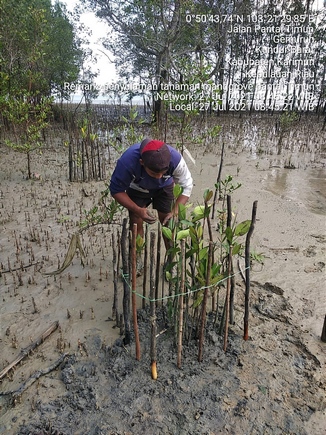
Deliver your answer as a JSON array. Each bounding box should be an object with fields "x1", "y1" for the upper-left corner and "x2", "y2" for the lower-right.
[{"x1": 110, "y1": 143, "x2": 193, "y2": 197}]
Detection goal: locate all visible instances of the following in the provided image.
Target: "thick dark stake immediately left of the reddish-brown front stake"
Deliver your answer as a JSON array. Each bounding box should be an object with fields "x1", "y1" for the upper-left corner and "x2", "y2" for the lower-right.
[{"x1": 120, "y1": 218, "x2": 130, "y2": 345}]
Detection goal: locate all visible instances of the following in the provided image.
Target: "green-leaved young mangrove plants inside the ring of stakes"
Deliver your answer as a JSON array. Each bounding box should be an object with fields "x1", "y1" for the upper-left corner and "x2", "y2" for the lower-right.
[{"x1": 162, "y1": 181, "x2": 255, "y2": 361}]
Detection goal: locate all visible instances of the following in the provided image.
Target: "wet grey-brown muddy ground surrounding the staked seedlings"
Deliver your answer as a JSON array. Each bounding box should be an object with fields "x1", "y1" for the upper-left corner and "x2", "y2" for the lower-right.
[{"x1": 0, "y1": 114, "x2": 326, "y2": 435}]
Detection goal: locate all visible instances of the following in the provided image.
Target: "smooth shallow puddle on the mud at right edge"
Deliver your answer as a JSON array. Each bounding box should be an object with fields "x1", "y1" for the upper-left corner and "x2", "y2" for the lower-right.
[{"x1": 262, "y1": 168, "x2": 326, "y2": 215}]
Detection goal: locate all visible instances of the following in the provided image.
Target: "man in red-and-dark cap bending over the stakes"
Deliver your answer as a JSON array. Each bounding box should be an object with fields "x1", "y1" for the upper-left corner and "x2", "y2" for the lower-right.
[{"x1": 110, "y1": 138, "x2": 193, "y2": 247}]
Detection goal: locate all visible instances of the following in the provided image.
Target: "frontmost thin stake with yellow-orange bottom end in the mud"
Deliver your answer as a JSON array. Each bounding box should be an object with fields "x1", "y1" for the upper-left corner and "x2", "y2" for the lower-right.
[{"x1": 149, "y1": 232, "x2": 157, "y2": 380}]
